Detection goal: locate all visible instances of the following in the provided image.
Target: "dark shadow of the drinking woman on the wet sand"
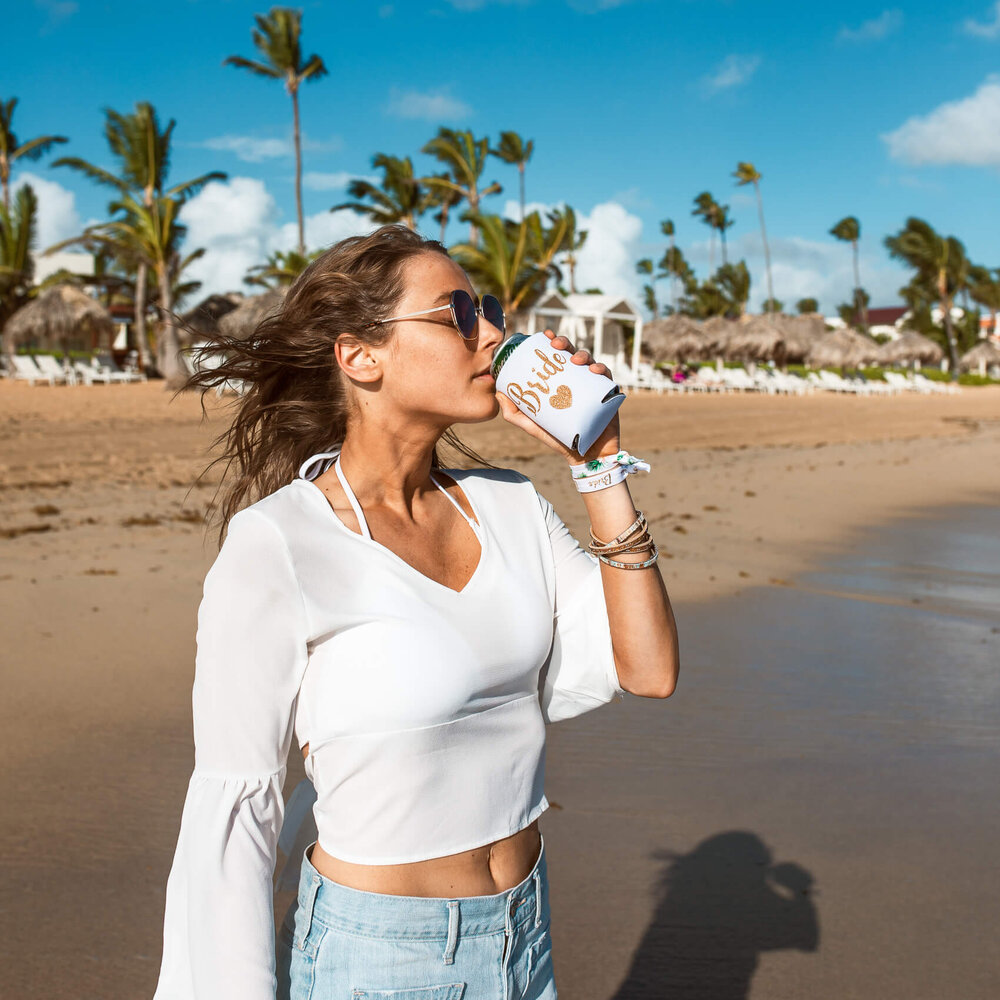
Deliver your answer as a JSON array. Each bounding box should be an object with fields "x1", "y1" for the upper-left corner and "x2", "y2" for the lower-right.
[{"x1": 611, "y1": 830, "x2": 819, "y2": 1000}]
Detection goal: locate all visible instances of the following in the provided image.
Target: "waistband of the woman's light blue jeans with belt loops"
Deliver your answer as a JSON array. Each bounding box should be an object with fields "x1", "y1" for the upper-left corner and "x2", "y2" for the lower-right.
[{"x1": 298, "y1": 834, "x2": 549, "y2": 940}]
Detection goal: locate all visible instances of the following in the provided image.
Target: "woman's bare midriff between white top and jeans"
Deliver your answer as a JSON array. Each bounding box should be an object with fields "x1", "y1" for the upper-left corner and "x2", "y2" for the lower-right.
[{"x1": 302, "y1": 743, "x2": 542, "y2": 898}]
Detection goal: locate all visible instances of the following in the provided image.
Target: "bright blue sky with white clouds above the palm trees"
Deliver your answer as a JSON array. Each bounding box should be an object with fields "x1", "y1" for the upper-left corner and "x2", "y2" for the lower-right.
[{"x1": 7, "y1": 0, "x2": 1000, "y2": 313}]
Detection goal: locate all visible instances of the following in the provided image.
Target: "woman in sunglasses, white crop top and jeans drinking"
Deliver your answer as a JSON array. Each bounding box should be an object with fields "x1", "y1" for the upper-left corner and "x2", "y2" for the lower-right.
[{"x1": 155, "y1": 226, "x2": 678, "y2": 1000}]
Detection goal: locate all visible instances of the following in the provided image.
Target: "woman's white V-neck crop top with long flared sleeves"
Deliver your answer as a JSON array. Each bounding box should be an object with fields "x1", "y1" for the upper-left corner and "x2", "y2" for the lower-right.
[{"x1": 154, "y1": 452, "x2": 624, "y2": 1000}]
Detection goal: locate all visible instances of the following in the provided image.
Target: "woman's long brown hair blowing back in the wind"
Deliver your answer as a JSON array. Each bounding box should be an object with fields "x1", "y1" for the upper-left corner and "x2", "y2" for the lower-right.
[{"x1": 178, "y1": 225, "x2": 496, "y2": 543}]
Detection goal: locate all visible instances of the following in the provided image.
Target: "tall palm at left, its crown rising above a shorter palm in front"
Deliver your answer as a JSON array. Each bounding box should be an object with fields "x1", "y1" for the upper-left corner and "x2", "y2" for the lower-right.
[{"x1": 52, "y1": 101, "x2": 227, "y2": 368}]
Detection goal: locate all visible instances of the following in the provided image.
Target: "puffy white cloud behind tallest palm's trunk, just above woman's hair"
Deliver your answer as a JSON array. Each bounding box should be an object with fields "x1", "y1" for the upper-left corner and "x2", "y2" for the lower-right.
[{"x1": 181, "y1": 177, "x2": 375, "y2": 295}]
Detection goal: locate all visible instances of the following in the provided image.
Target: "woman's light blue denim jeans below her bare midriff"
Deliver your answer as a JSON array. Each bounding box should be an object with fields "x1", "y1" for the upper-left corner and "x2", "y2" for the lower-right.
[{"x1": 277, "y1": 840, "x2": 557, "y2": 1000}]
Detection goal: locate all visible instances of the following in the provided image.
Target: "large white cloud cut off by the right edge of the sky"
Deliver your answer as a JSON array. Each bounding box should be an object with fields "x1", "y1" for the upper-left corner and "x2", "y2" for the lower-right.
[{"x1": 882, "y1": 73, "x2": 1000, "y2": 167}]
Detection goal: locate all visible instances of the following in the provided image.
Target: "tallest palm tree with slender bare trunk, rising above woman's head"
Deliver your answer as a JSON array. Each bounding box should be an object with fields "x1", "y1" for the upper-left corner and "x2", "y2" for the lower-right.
[{"x1": 222, "y1": 7, "x2": 327, "y2": 254}]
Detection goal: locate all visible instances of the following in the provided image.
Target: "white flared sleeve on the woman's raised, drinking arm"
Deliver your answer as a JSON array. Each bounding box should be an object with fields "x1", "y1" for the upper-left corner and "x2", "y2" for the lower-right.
[{"x1": 535, "y1": 490, "x2": 625, "y2": 723}]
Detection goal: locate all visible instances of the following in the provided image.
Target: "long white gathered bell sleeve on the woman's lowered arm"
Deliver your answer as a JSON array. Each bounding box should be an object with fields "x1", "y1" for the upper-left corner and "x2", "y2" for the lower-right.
[{"x1": 153, "y1": 508, "x2": 307, "y2": 1000}]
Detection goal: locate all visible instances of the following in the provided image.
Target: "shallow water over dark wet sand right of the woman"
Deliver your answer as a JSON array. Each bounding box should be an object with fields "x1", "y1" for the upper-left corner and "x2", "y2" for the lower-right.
[{"x1": 543, "y1": 506, "x2": 1000, "y2": 1000}]
